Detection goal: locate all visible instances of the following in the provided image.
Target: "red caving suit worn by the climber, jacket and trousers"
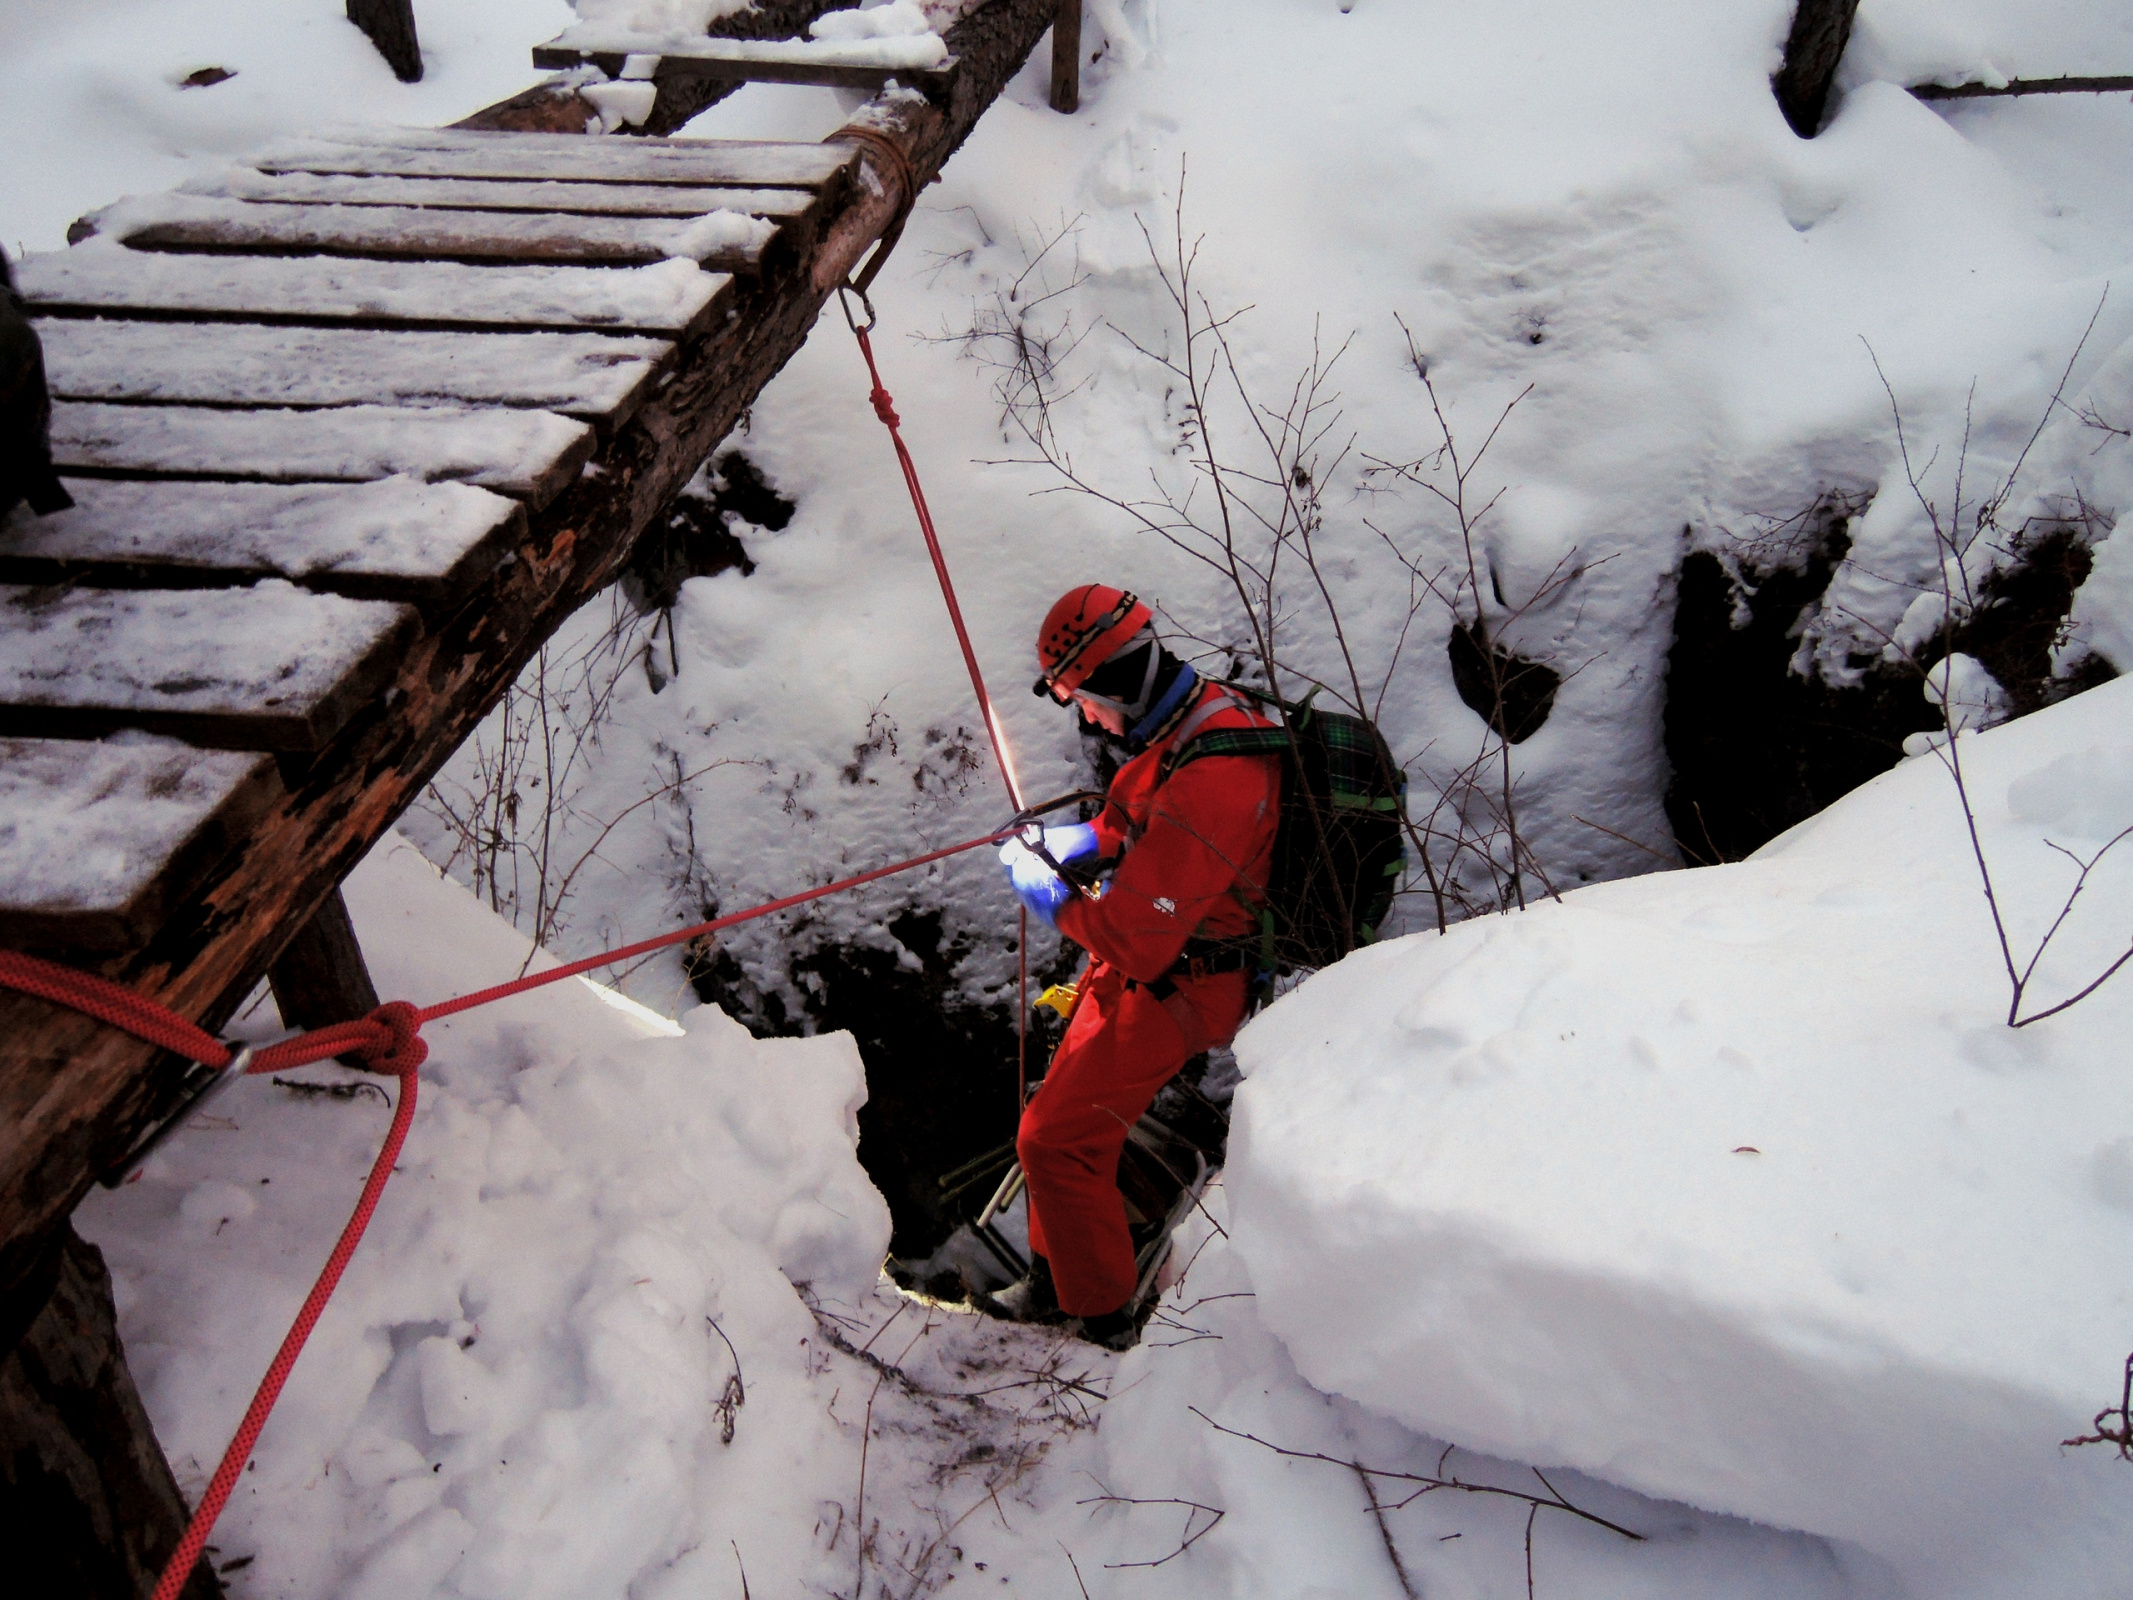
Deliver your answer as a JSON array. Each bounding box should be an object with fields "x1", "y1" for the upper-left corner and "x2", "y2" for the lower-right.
[{"x1": 1017, "y1": 685, "x2": 1282, "y2": 1316}]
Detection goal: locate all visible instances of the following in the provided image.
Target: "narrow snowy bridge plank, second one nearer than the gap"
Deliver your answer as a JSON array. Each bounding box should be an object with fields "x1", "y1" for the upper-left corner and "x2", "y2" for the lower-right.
[{"x1": 183, "y1": 166, "x2": 817, "y2": 222}]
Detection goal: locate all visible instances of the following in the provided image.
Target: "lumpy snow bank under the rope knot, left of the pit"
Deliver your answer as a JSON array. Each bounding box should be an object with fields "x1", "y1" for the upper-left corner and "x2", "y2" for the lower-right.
[{"x1": 79, "y1": 838, "x2": 887, "y2": 1600}]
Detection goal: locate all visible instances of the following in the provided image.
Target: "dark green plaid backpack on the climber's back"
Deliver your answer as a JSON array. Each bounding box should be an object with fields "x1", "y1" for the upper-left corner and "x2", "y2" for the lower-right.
[{"x1": 1162, "y1": 683, "x2": 1408, "y2": 979}]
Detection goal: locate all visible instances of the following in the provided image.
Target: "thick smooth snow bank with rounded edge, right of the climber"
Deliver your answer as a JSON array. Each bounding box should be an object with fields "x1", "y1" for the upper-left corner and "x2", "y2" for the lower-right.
[{"x1": 1229, "y1": 681, "x2": 2133, "y2": 1596}]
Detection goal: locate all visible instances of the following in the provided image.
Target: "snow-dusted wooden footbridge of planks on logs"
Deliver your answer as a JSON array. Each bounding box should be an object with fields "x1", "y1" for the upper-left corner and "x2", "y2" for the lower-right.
[{"x1": 0, "y1": 0, "x2": 1079, "y2": 1596}]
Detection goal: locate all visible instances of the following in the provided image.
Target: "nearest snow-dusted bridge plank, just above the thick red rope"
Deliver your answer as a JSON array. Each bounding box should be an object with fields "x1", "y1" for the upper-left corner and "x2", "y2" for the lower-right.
[{"x1": 0, "y1": 734, "x2": 282, "y2": 949}]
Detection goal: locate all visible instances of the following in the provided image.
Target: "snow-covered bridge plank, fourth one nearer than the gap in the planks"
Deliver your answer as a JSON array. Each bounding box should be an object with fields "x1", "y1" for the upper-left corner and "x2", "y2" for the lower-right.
[{"x1": 15, "y1": 239, "x2": 734, "y2": 337}]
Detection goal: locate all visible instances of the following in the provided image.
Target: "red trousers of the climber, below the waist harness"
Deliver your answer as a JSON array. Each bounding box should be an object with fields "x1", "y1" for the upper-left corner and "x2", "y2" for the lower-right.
[{"x1": 1015, "y1": 969, "x2": 1244, "y2": 1316}]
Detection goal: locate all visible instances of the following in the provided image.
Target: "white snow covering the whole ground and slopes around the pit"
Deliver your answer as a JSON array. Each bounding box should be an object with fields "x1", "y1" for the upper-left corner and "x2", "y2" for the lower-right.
[{"x1": 12, "y1": 0, "x2": 2133, "y2": 1600}]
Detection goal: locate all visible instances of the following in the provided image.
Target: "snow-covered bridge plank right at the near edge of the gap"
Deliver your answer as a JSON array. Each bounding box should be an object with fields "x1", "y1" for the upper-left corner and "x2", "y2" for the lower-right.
[{"x1": 250, "y1": 128, "x2": 857, "y2": 190}]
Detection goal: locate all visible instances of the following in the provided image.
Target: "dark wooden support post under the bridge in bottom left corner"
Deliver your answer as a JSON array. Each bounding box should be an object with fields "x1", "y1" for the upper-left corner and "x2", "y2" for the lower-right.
[{"x1": 0, "y1": 1229, "x2": 222, "y2": 1600}]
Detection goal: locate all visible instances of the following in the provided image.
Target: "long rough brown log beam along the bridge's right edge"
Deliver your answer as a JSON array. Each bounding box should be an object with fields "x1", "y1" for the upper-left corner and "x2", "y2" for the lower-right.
[{"x1": 0, "y1": 0, "x2": 1052, "y2": 1382}]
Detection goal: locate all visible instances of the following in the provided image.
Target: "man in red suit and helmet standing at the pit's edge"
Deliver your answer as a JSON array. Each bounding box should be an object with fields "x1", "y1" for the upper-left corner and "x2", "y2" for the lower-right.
[{"x1": 1000, "y1": 585, "x2": 1282, "y2": 1346}]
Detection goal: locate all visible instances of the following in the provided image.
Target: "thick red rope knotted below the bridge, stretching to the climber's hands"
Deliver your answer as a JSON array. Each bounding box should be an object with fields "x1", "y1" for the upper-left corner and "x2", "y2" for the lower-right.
[{"x1": 0, "y1": 830, "x2": 1013, "y2": 1600}]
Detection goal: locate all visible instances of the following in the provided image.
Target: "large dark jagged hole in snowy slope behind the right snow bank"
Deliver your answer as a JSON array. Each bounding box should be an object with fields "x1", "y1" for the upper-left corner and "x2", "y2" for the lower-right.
[{"x1": 1664, "y1": 506, "x2": 2112, "y2": 864}]
